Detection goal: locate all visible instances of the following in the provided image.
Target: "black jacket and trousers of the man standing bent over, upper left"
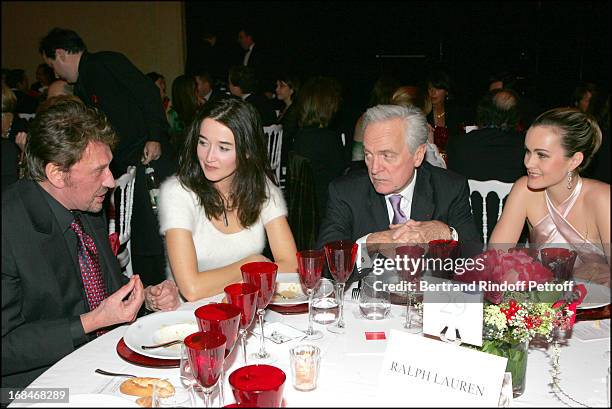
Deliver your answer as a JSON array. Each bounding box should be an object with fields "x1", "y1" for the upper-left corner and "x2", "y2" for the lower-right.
[{"x1": 74, "y1": 51, "x2": 176, "y2": 270}]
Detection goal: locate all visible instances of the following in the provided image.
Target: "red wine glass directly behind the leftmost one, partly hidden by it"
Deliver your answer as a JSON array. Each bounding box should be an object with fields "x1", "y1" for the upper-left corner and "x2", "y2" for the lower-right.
[{"x1": 195, "y1": 303, "x2": 242, "y2": 402}]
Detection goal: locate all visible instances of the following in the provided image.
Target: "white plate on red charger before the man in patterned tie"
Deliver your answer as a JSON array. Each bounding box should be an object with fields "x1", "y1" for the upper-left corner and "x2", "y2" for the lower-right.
[{"x1": 123, "y1": 310, "x2": 198, "y2": 359}]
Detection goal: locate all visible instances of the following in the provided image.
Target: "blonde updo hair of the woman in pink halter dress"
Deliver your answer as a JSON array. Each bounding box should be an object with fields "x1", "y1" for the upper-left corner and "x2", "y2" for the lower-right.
[{"x1": 531, "y1": 108, "x2": 602, "y2": 173}]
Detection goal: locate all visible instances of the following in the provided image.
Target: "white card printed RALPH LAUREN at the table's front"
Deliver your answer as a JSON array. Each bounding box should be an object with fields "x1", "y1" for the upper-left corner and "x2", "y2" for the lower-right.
[{"x1": 377, "y1": 329, "x2": 507, "y2": 407}]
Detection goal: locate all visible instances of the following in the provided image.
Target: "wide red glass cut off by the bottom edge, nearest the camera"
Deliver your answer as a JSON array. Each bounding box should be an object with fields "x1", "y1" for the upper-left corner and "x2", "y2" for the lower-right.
[{"x1": 229, "y1": 365, "x2": 287, "y2": 408}]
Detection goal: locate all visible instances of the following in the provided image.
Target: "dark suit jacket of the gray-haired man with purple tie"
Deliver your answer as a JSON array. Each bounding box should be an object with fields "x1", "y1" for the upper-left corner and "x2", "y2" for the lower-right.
[{"x1": 317, "y1": 162, "x2": 480, "y2": 248}]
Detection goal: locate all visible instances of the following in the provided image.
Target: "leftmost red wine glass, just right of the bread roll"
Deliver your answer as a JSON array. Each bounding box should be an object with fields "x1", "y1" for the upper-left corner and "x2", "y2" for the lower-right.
[{"x1": 184, "y1": 331, "x2": 227, "y2": 408}]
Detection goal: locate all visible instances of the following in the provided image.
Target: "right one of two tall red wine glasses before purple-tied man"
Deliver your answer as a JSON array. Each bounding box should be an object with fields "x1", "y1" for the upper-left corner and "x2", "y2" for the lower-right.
[{"x1": 325, "y1": 240, "x2": 357, "y2": 334}]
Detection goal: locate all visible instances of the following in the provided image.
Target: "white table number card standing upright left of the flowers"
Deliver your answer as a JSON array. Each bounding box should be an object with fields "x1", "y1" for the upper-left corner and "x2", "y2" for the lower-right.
[{"x1": 423, "y1": 277, "x2": 483, "y2": 346}]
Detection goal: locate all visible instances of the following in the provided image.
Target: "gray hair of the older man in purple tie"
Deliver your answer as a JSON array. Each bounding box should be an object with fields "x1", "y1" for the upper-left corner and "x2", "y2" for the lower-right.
[{"x1": 363, "y1": 105, "x2": 429, "y2": 154}]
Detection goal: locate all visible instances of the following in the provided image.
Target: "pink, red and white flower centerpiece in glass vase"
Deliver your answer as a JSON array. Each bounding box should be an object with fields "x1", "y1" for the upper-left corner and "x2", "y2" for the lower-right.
[{"x1": 455, "y1": 250, "x2": 586, "y2": 397}]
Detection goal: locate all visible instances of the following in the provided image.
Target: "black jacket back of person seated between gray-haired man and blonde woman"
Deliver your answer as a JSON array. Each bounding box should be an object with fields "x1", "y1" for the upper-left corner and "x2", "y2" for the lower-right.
[{"x1": 446, "y1": 128, "x2": 525, "y2": 183}]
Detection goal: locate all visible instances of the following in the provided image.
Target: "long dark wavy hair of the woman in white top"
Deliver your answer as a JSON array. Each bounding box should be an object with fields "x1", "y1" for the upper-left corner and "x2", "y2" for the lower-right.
[{"x1": 178, "y1": 98, "x2": 275, "y2": 228}]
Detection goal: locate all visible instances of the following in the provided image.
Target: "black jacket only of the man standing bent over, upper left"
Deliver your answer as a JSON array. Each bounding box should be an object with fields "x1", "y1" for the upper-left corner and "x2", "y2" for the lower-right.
[{"x1": 74, "y1": 51, "x2": 168, "y2": 177}]
